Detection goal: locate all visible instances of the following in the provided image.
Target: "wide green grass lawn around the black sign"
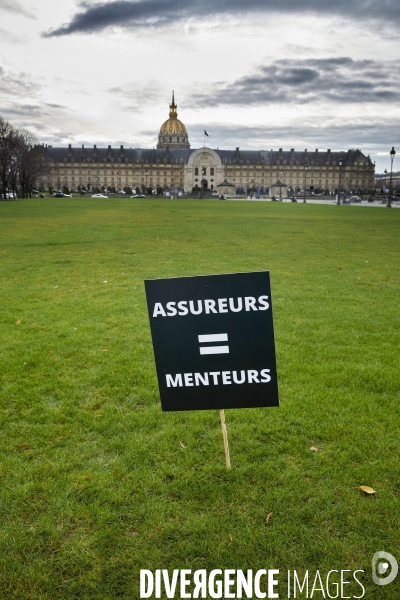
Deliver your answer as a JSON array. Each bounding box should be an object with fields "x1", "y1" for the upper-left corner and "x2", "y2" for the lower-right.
[{"x1": 0, "y1": 198, "x2": 400, "y2": 600}]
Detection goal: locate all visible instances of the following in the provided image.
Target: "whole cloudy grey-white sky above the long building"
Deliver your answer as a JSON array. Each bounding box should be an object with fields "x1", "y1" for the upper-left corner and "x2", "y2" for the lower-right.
[{"x1": 0, "y1": 0, "x2": 400, "y2": 172}]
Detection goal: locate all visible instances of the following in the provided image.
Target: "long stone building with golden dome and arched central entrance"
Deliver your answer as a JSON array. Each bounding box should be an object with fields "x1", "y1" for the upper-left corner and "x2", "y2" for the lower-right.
[{"x1": 41, "y1": 95, "x2": 374, "y2": 195}]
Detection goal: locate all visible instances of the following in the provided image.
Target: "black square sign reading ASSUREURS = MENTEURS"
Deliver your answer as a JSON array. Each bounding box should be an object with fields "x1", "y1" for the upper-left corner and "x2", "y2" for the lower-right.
[{"x1": 145, "y1": 271, "x2": 279, "y2": 411}]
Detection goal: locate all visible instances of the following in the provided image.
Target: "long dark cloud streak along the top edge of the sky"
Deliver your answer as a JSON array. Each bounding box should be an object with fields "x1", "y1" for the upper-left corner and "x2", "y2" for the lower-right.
[{"x1": 42, "y1": 0, "x2": 400, "y2": 37}]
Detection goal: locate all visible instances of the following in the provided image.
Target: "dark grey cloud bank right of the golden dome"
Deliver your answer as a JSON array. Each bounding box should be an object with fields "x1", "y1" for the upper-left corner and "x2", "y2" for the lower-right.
[{"x1": 191, "y1": 57, "x2": 400, "y2": 108}]
